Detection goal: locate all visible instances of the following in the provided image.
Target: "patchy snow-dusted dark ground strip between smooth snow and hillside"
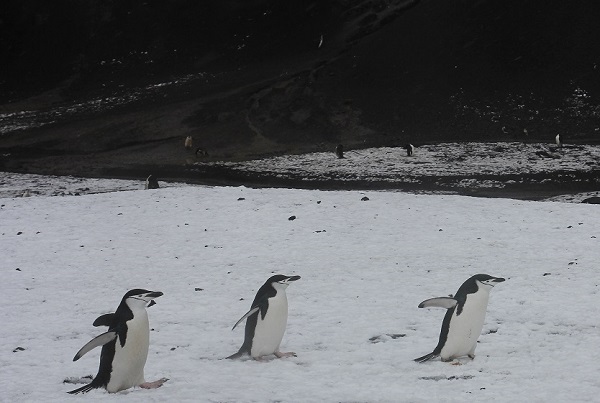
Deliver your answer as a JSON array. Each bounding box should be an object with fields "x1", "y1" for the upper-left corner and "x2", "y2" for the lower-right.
[{"x1": 0, "y1": 142, "x2": 600, "y2": 203}]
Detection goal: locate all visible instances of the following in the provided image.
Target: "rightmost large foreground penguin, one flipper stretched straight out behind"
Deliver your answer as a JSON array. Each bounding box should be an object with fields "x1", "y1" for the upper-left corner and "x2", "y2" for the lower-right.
[{"x1": 414, "y1": 274, "x2": 504, "y2": 362}]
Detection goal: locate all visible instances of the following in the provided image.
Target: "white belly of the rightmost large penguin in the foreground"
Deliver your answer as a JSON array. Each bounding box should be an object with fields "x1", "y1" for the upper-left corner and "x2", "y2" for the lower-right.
[{"x1": 440, "y1": 291, "x2": 489, "y2": 360}]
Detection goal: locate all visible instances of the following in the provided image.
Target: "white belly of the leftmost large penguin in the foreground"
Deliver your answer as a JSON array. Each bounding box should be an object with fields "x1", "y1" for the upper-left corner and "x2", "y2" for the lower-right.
[{"x1": 106, "y1": 310, "x2": 150, "y2": 393}]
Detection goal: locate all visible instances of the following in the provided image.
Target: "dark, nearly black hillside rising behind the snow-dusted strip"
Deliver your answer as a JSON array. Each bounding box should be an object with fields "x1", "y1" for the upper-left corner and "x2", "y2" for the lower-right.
[{"x1": 0, "y1": 0, "x2": 600, "y2": 175}]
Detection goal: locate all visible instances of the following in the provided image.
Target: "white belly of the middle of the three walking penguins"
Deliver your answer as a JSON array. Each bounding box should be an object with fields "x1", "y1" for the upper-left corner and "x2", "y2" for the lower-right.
[{"x1": 250, "y1": 292, "x2": 288, "y2": 358}]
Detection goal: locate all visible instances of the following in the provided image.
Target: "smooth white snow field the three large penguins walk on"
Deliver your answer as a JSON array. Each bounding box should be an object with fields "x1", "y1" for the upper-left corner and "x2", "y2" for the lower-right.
[{"x1": 0, "y1": 175, "x2": 600, "y2": 402}]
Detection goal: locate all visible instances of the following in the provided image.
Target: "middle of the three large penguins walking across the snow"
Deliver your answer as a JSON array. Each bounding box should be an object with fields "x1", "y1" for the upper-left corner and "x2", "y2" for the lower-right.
[{"x1": 227, "y1": 274, "x2": 300, "y2": 359}]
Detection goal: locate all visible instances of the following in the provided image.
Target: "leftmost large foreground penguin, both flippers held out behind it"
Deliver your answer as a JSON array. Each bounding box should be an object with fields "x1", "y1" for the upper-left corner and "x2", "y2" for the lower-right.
[{"x1": 69, "y1": 289, "x2": 167, "y2": 394}]
